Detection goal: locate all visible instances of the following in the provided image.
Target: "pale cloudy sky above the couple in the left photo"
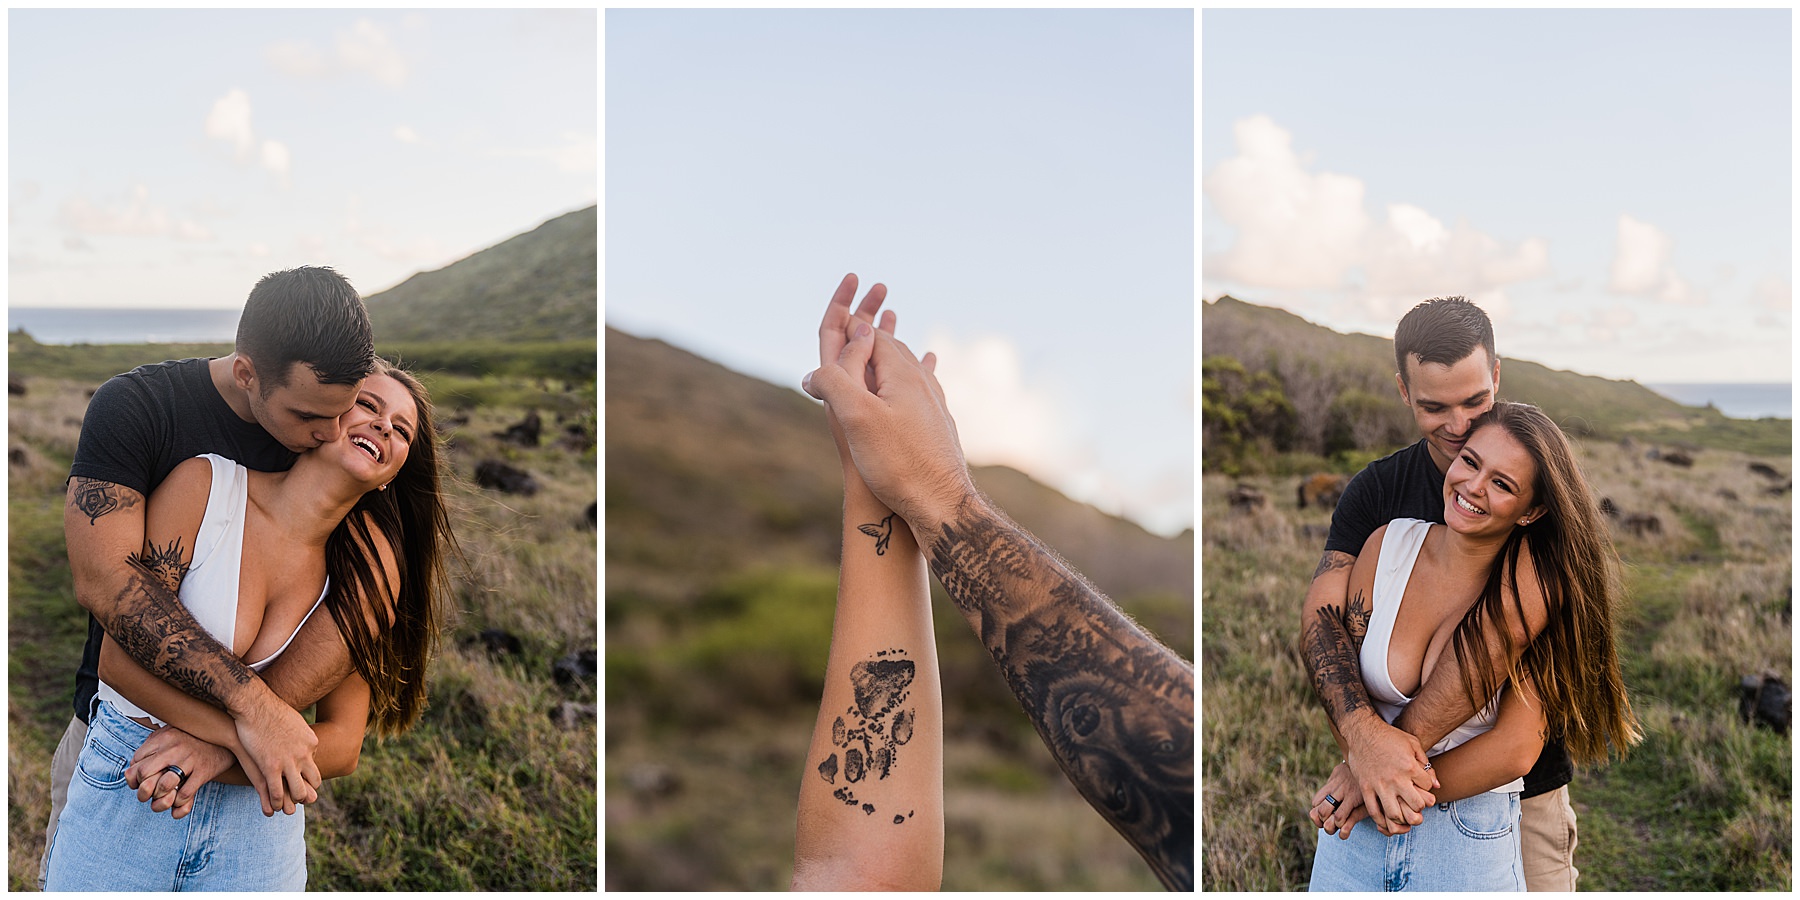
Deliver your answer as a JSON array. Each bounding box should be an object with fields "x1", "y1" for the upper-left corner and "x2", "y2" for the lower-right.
[{"x1": 7, "y1": 9, "x2": 599, "y2": 308}]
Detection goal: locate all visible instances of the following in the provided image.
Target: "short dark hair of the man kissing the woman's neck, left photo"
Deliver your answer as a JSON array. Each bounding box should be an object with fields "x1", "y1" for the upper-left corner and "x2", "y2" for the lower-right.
[{"x1": 236, "y1": 266, "x2": 374, "y2": 396}]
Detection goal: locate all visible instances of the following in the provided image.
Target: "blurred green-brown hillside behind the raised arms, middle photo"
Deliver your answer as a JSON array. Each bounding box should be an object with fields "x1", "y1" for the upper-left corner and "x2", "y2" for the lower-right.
[{"x1": 605, "y1": 328, "x2": 1193, "y2": 889}]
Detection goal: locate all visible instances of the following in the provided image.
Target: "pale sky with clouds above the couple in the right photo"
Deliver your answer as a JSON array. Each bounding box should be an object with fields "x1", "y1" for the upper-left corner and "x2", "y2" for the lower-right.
[{"x1": 1201, "y1": 9, "x2": 1793, "y2": 382}]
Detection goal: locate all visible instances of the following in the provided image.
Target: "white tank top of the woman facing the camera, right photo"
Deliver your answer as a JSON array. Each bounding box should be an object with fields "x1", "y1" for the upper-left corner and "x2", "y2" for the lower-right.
[{"x1": 1357, "y1": 518, "x2": 1525, "y2": 794}]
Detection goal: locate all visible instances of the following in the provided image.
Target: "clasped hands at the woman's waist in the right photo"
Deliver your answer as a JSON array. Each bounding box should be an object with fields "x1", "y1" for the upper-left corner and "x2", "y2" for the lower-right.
[{"x1": 1307, "y1": 716, "x2": 1440, "y2": 841}]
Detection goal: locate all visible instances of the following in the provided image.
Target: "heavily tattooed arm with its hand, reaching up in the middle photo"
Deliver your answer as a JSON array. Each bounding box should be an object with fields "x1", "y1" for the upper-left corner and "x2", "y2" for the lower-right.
[{"x1": 803, "y1": 275, "x2": 1193, "y2": 891}]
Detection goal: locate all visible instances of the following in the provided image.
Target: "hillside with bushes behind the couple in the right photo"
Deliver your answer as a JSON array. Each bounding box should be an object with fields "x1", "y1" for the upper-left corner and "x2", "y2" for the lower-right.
[{"x1": 1201, "y1": 297, "x2": 1793, "y2": 472}]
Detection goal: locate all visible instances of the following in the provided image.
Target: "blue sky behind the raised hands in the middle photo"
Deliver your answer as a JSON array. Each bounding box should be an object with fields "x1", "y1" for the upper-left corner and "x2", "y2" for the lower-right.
[{"x1": 605, "y1": 9, "x2": 1195, "y2": 533}]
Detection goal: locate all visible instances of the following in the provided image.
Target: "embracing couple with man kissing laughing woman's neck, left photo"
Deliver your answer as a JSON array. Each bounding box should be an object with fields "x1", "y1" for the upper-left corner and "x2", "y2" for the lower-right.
[{"x1": 40, "y1": 266, "x2": 454, "y2": 891}]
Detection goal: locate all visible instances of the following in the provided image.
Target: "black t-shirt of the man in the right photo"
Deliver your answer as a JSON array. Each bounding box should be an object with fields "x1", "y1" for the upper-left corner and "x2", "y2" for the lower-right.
[{"x1": 1325, "y1": 439, "x2": 1575, "y2": 797}]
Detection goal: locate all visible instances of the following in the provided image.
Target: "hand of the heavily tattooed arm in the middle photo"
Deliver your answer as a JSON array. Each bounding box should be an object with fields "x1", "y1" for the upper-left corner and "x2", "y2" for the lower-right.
[{"x1": 801, "y1": 309, "x2": 976, "y2": 533}]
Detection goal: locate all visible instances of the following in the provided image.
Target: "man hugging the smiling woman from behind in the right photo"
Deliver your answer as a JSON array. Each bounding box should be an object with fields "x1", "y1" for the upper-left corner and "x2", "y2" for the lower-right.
[{"x1": 1301, "y1": 297, "x2": 1577, "y2": 891}]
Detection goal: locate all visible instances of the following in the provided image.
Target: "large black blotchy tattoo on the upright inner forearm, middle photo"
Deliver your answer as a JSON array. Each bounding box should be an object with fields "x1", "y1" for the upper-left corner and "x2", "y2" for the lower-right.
[{"x1": 817, "y1": 651, "x2": 918, "y2": 824}]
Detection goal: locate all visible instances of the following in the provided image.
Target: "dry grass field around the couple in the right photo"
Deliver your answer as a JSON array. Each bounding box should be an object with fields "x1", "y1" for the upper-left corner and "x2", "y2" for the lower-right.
[{"x1": 1201, "y1": 441, "x2": 1793, "y2": 891}]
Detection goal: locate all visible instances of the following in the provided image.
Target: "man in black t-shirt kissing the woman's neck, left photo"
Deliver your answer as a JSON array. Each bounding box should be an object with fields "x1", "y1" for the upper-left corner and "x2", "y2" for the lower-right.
[{"x1": 45, "y1": 266, "x2": 392, "y2": 878}]
